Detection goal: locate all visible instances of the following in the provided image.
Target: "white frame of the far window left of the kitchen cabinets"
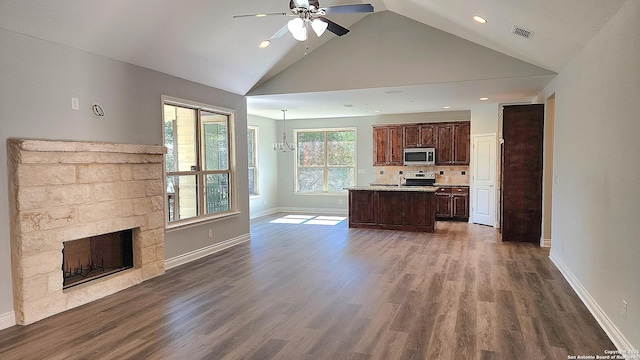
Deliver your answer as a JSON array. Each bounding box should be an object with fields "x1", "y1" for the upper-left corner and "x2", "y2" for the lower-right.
[{"x1": 293, "y1": 126, "x2": 358, "y2": 196}]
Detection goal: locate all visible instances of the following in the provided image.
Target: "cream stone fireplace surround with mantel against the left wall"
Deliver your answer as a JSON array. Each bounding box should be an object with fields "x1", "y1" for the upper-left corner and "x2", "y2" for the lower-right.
[{"x1": 7, "y1": 139, "x2": 165, "y2": 325}]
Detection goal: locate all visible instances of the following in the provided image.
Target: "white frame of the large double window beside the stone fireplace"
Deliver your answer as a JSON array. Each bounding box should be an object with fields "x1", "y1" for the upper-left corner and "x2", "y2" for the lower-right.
[{"x1": 161, "y1": 95, "x2": 239, "y2": 229}]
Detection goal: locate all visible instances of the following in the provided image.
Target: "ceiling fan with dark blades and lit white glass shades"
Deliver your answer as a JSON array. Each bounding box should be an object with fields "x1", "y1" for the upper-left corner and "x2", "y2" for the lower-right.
[{"x1": 233, "y1": 0, "x2": 373, "y2": 41}]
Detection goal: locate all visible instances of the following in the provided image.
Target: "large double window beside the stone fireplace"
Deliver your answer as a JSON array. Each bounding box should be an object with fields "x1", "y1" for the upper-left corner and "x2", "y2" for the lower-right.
[{"x1": 163, "y1": 97, "x2": 234, "y2": 223}]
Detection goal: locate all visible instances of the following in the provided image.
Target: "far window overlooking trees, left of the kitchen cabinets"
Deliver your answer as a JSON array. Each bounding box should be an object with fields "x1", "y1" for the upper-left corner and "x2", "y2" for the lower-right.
[{"x1": 295, "y1": 129, "x2": 356, "y2": 193}]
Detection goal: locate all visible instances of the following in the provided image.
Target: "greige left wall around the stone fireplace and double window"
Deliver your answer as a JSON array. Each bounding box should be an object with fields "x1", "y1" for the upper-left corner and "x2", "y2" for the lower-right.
[{"x1": 0, "y1": 29, "x2": 249, "y2": 326}]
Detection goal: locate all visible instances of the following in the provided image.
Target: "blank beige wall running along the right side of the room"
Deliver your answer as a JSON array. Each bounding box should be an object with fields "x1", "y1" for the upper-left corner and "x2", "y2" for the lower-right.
[{"x1": 541, "y1": 0, "x2": 640, "y2": 349}]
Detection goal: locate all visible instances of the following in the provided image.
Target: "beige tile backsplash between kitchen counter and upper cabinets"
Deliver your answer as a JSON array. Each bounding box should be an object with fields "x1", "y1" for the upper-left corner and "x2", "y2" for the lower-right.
[{"x1": 373, "y1": 166, "x2": 469, "y2": 185}]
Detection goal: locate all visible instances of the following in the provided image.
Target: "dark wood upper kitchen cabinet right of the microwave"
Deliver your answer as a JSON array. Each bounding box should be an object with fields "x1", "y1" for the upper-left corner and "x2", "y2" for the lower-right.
[{"x1": 436, "y1": 121, "x2": 471, "y2": 165}]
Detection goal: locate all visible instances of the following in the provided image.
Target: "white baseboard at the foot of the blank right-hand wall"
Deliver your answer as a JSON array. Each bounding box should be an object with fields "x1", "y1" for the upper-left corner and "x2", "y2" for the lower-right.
[{"x1": 549, "y1": 249, "x2": 636, "y2": 353}]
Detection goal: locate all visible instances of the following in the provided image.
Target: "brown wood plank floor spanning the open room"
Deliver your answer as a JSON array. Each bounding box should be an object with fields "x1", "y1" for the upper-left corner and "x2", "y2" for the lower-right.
[{"x1": 0, "y1": 214, "x2": 614, "y2": 360}]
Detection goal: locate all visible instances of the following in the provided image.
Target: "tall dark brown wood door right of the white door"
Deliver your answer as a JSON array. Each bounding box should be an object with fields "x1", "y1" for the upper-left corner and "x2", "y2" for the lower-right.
[{"x1": 502, "y1": 104, "x2": 544, "y2": 244}]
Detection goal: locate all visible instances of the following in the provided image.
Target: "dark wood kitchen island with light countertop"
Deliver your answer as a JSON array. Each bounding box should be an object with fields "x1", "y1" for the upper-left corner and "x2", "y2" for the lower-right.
[{"x1": 348, "y1": 186, "x2": 438, "y2": 232}]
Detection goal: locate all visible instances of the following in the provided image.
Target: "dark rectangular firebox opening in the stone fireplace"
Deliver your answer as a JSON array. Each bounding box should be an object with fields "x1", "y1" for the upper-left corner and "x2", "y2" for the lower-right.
[{"x1": 62, "y1": 229, "x2": 133, "y2": 289}]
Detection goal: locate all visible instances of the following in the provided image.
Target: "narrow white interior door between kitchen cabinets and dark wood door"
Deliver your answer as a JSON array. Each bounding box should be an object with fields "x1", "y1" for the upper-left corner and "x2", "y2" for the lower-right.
[{"x1": 472, "y1": 134, "x2": 496, "y2": 226}]
